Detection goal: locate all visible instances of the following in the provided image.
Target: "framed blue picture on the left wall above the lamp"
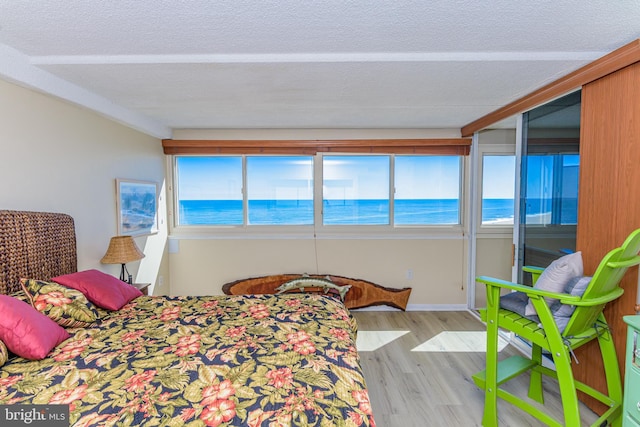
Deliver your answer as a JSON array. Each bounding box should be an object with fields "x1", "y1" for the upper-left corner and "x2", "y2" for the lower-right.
[{"x1": 116, "y1": 179, "x2": 158, "y2": 236}]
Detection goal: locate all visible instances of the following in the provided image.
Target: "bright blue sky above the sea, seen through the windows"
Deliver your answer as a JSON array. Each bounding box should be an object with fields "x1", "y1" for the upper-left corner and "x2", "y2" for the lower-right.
[{"x1": 177, "y1": 156, "x2": 513, "y2": 200}]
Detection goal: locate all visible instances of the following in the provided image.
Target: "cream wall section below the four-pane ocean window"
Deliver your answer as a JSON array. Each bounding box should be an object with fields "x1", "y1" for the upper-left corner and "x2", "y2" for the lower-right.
[{"x1": 170, "y1": 238, "x2": 467, "y2": 309}]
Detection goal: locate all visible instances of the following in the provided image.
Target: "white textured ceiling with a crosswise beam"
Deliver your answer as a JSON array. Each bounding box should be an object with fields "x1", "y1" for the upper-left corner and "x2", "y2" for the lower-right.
[{"x1": 0, "y1": 0, "x2": 640, "y2": 138}]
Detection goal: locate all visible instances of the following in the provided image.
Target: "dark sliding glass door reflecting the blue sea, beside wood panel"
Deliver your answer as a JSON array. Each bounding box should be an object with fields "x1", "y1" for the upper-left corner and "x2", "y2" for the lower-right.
[{"x1": 517, "y1": 91, "x2": 581, "y2": 283}]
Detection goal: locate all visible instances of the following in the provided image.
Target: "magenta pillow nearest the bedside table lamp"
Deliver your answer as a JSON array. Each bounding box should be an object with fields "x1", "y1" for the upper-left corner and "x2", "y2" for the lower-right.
[{"x1": 51, "y1": 270, "x2": 142, "y2": 310}]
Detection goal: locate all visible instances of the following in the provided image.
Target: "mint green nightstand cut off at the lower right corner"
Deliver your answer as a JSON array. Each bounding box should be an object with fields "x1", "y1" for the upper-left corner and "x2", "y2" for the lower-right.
[{"x1": 622, "y1": 316, "x2": 640, "y2": 427}]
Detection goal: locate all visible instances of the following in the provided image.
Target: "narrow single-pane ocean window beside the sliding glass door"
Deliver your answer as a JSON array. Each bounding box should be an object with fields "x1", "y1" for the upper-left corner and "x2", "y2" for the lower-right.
[{"x1": 482, "y1": 154, "x2": 516, "y2": 225}]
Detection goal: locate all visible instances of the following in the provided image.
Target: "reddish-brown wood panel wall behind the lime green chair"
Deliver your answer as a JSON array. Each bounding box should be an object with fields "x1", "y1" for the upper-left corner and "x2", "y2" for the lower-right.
[{"x1": 573, "y1": 62, "x2": 640, "y2": 412}]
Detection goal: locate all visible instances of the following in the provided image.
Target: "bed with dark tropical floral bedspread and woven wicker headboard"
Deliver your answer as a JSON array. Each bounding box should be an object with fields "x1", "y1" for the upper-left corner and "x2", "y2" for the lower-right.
[{"x1": 0, "y1": 211, "x2": 375, "y2": 427}]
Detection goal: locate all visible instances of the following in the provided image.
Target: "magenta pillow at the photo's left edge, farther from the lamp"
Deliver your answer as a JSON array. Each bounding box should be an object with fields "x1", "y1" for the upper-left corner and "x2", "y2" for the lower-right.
[{"x1": 0, "y1": 295, "x2": 69, "y2": 360}]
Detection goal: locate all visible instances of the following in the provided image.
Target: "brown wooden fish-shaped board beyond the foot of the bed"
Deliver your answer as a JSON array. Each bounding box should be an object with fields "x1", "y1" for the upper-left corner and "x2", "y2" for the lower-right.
[{"x1": 222, "y1": 274, "x2": 411, "y2": 310}]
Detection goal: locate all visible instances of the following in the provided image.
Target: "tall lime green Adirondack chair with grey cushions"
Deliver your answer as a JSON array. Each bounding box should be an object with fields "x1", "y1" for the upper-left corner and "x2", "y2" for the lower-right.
[{"x1": 473, "y1": 229, "x2": 640, "y2": 426}]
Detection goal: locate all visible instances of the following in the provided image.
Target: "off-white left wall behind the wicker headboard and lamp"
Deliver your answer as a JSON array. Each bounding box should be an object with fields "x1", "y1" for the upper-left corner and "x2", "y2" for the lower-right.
[{"x1": 0, "y1": 80, "x2": 168, "y2": 293}]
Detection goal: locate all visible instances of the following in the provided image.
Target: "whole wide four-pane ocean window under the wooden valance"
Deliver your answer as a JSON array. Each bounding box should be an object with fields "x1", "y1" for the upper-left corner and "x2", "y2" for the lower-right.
[{"x1": 174, "y1": 154, "x2": 462, "y2": 227}]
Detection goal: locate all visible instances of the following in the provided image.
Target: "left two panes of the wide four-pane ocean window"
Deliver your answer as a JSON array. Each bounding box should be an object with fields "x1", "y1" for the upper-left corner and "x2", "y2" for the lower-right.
[{"x1": 176, "y1": 156, "x2": 313, "y2": 225}]
